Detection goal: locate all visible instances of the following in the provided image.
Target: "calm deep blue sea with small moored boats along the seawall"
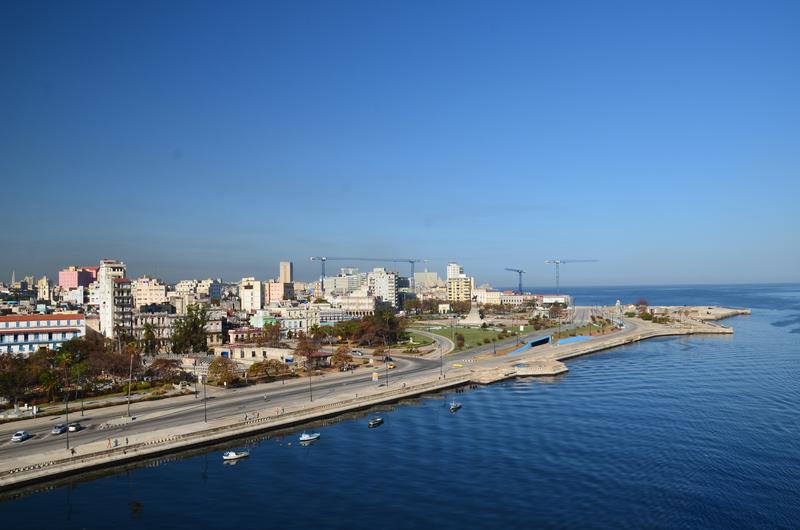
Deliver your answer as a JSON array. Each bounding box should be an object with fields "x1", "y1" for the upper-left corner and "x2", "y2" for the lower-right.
[{"x1": 0, "y1": 285, "x2": 800, "y2": 529}]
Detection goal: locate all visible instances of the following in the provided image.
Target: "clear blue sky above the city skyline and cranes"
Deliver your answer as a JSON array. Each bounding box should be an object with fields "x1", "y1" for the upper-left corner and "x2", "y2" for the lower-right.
[{"x1": 0, "y1": 0, "x2": 800, "y2": 285}]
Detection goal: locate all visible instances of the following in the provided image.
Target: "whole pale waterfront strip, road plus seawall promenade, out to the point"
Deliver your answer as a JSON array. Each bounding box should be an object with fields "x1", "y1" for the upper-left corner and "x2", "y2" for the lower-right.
[{"x1": 0, "y1": 310, "x2": 739, "y2": 489}]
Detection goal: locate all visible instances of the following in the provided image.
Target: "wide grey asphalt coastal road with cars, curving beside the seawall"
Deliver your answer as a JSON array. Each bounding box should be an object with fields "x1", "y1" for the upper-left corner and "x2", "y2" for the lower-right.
[{"x1": 0, "y1": 318, "x2": 580, "y2": 461}]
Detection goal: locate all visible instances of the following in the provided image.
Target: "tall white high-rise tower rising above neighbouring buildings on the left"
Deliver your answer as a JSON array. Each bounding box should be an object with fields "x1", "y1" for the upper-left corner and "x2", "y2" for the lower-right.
[{"x1": 97, "y1": 259, "x2": 133, "y2": 338}]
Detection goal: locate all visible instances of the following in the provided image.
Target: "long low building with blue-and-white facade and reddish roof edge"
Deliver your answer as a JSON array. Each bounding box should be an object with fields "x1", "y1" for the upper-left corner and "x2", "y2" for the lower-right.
[{"x1": 0, "y1": 313, "x2": 86, "y2": 355}]
